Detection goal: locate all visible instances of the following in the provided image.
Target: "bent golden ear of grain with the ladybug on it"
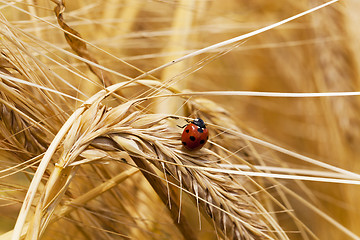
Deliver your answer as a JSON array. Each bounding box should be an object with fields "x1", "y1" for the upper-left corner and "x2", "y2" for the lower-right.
[{"x1": 12, "y1": 91, "x2": 284, "y2": 239}]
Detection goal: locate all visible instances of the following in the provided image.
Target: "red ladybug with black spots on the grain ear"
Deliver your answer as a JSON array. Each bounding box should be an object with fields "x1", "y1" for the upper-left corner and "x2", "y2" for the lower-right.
[{"x1": 179, "y1": 118, "x2": 209, "y2": 150}]
